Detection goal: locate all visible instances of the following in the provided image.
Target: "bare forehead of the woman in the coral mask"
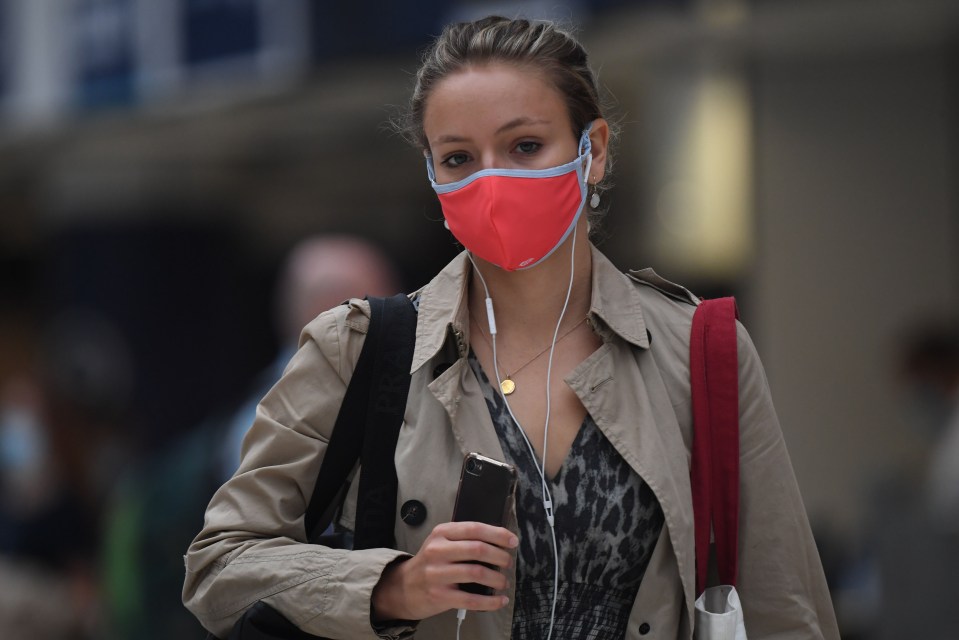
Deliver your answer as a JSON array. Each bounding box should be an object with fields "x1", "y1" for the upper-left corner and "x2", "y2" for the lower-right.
[{"x1": 423, "y1": 63, "x2": 570, "y2": 140}]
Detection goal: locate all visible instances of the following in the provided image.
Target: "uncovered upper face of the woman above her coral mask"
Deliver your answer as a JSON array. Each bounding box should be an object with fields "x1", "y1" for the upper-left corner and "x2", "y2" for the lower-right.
[{"x1": 423, "y1": 63, "x2": 605, "y2": 184}]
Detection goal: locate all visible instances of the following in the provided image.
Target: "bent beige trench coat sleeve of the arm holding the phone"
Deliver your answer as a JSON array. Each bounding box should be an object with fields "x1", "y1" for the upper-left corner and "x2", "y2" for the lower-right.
[{"x1": 183, "y1": 303, "x2": 407, "y2": 638}]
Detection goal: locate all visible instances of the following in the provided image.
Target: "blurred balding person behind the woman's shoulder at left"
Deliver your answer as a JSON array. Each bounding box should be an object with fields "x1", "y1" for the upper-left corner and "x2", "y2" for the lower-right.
[{"x1": 104, "y1": 235, "x2": 399, "y2": 640}]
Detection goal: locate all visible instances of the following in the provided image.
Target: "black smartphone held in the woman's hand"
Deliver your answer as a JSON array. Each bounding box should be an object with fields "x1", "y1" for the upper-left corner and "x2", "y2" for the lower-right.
[{"x1": 453, "y1": 453, "x2": 516, "y2": 596}]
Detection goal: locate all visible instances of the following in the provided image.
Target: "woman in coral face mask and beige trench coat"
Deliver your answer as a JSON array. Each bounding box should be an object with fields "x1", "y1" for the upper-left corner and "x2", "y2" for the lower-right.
[{"x1": 184, "y1": 17, "x2": 838, "y2": 639}]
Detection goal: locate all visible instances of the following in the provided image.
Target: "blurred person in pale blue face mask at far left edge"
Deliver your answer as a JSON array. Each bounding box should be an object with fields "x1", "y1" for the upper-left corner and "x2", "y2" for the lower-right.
[{"x1": 0, "y1": 310, "x2": 132, "y2": 639}]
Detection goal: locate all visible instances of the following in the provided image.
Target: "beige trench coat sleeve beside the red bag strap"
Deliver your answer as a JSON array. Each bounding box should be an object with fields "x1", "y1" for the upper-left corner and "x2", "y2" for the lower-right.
[{"x1": 737, "y1": 325, "x2": 839, "y2": 640}]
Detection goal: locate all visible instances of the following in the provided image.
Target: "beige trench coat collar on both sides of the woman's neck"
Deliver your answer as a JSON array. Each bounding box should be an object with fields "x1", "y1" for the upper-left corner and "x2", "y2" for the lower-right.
[{"x1": 411, "y1": 245, "x2": 649, "y2": 371}]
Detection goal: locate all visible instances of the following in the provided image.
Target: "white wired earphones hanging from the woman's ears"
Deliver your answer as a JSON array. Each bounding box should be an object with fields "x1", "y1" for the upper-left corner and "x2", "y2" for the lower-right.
[{"x1": 456, "y1": 154, "x2": 593, "y2": 640}]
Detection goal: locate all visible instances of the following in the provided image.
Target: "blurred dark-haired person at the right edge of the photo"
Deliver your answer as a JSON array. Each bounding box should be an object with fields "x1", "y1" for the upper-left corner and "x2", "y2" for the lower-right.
[{"x1": 835, "y1": 319, "x2": 959, "y2": 640}]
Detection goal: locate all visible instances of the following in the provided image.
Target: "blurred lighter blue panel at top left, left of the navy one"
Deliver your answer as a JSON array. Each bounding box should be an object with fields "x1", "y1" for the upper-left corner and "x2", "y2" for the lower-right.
[{"x1": 70, "y1": 0, "x2": 135, "y2": 108}]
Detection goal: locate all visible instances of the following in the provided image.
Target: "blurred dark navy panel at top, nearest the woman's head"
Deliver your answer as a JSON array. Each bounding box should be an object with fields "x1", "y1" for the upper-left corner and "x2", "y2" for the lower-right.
[{"x1": 182, "y1": 0, "x2": 261, "y2": 65}]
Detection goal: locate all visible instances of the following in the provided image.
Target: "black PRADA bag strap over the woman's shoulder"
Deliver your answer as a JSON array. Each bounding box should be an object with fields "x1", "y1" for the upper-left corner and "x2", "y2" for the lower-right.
[{"x1": 305, "y1": 294, "x2": 416, "y2": 549}]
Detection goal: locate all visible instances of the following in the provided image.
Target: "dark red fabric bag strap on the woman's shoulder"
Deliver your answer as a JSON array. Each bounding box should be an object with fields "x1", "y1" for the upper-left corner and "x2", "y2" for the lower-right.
[{"x1": 689, "y1": 298, "x2": 739, "y2": 596}]
